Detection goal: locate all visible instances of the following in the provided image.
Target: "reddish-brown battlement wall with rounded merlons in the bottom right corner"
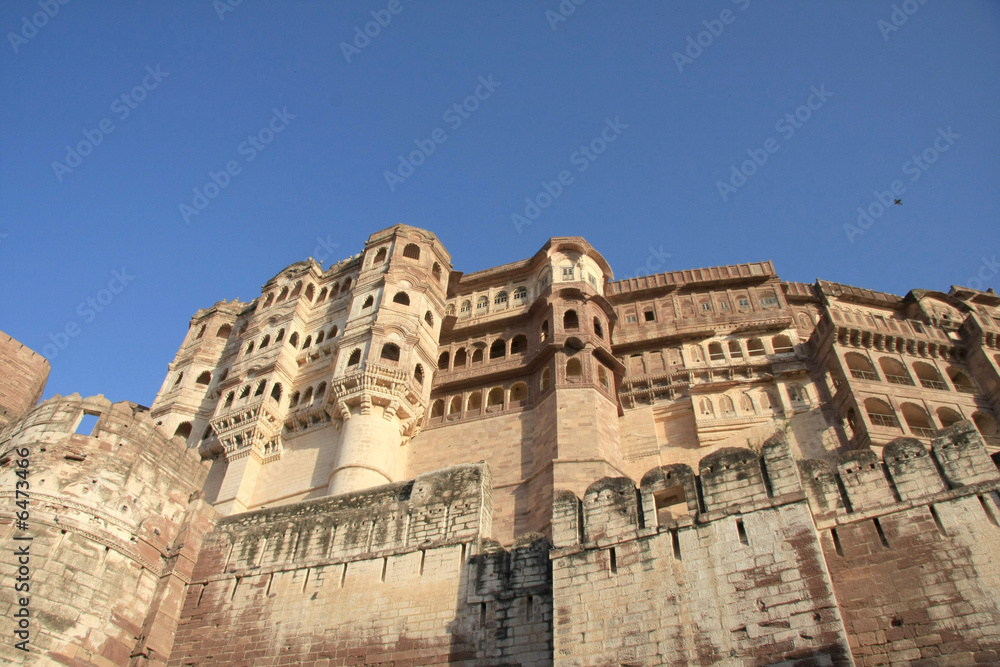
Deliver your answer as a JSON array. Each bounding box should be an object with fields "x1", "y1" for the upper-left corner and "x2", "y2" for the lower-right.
[{"x1": 800, "y1": 422, "x2": 1000, "y2": 665}]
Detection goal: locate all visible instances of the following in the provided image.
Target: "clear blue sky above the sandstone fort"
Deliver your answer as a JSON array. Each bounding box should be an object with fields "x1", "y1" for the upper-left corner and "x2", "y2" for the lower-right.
[{"x1": 0, "y1": 0, "x2": 1000, "y2": 405}]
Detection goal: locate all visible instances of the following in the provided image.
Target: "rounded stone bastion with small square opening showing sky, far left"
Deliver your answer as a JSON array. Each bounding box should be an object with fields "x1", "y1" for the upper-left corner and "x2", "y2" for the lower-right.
[{"x1": 0, "y1": 395, "x2": 216, "y2": 666}]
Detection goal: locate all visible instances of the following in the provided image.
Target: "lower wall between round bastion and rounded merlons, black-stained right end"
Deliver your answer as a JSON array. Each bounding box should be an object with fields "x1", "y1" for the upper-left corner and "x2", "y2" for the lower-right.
[{"x1": 170, "y1": 465, "x2": 551, "y2": 666}]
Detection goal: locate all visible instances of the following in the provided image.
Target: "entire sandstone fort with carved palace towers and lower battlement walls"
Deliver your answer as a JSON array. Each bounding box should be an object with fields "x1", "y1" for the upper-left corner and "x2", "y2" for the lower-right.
[{"x1": 0, "y1": 225, "x2": 1000, "y2": 667}]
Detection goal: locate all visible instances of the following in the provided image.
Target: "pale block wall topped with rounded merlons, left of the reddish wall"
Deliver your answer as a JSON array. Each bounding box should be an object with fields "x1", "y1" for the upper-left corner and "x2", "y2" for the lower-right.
[{"x1": 552, "y1": 438, "x2": 851, "y2": 665}]
